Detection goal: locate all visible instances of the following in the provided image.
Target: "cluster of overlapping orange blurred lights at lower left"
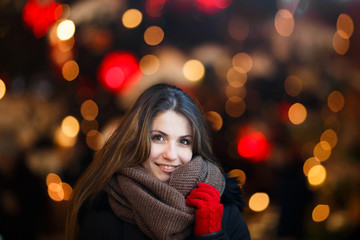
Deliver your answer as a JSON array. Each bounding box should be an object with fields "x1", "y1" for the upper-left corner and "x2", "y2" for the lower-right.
[{"x1": 46, "y1": 173, "x2": 73, "y2": 202}]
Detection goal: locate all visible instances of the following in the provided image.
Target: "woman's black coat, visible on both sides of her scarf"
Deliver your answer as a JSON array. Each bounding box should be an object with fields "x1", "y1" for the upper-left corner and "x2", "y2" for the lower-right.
[{"x1": 79, "y1": 177, "x2": 250, "y2": 240}]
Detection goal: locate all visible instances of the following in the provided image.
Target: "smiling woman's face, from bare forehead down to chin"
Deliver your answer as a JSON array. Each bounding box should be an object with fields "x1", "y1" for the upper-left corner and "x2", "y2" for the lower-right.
[{"x1": 142, "y1": 110, "x2": 193, "y2": 182}]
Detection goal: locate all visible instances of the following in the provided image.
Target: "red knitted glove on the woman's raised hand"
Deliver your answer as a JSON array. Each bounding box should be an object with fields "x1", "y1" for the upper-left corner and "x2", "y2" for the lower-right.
[{"x1": 185, "y1": 182, "x2": 224, "y2": 236}]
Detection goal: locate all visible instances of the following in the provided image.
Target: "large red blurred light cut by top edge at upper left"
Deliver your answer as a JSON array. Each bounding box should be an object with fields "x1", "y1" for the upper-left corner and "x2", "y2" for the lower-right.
[{"x1": 22, "y1": 0, "x2": 63, "y2": 38}]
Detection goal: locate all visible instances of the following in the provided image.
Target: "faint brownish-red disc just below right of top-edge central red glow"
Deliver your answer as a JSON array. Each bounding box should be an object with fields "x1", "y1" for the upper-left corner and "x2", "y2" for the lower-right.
[{"x1": 228, "y1": 16, "x2": 250, "y2": 41}]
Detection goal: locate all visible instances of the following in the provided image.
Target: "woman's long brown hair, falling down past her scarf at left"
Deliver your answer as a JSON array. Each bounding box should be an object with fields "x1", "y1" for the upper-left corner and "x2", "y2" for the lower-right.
[{"x1": 66, "y1": 84, "x2": 218, "y2": 239}]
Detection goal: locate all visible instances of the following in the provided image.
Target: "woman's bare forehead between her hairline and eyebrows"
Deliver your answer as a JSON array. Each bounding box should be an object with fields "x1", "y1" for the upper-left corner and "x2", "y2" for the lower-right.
[{"x1": 151, "y1": 110, "x2": 191, "y2": 135}]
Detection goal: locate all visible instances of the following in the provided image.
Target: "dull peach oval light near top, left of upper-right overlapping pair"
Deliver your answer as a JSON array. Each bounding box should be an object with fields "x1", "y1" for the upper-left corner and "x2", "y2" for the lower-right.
[{"x1": 275, "y1": 9, "x2": 295, "y2": 37}]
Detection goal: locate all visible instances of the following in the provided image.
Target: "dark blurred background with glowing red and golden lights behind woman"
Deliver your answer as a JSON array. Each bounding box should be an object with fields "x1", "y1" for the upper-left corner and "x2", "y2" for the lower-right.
[{"x1": 0, "y1": 0, "x2": 360, "y2": 240}]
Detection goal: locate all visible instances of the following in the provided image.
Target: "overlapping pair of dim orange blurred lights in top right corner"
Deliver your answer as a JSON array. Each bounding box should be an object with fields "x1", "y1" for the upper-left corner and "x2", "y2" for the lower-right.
[{"x1": 333, "y1": 13, "x2": 354, "y2": 55}]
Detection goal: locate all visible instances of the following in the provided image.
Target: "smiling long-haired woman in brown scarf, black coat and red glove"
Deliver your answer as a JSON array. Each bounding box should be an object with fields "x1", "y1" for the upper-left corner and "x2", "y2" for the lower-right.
[{"x1": 66, "y1": 84, "x2": 250, "y2": 239}]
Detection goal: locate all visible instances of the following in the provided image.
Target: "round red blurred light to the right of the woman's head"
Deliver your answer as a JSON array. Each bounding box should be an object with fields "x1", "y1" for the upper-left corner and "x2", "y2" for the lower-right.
[{"x1": 237, "y1": 132, "x2": 271, "y2": 162}]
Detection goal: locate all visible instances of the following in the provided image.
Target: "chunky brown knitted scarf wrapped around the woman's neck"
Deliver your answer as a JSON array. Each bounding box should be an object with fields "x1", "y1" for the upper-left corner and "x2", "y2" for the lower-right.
[{"x1": 106, "y1": 157, "x2": 225, "y2": 240}]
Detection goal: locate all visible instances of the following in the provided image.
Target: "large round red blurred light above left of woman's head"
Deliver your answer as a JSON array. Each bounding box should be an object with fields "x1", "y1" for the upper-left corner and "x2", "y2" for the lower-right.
[{"x1": 98, "y1": 52, "x2": 142, "y2": 93}]
